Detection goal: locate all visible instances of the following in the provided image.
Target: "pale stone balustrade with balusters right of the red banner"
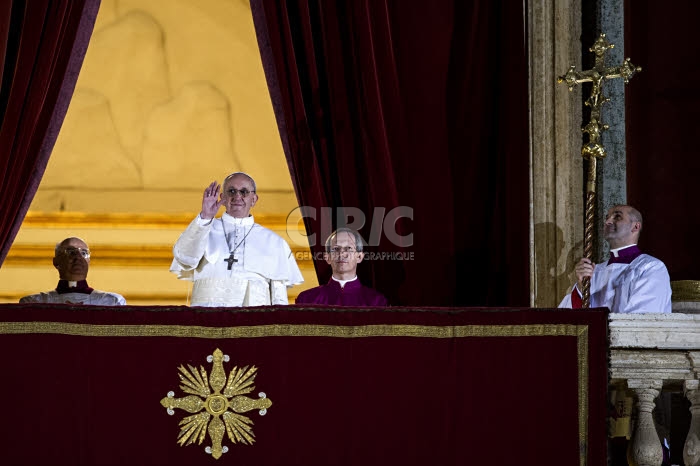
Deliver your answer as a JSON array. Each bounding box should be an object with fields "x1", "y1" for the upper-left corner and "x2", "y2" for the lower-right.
[{"x1": 609, "y1": 312, "x2": 700, "y2": 466}]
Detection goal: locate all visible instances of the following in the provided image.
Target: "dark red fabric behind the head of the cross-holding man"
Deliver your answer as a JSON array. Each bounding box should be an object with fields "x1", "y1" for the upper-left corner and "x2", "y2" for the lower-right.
[{"x1": 625, "y1": 0, "x2": 700, "y2": 280}]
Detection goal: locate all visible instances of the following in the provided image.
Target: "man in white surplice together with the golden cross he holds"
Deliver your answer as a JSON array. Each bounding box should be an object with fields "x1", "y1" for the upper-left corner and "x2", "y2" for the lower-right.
[{"x1": 559, "y1": 34, "x2": 671, "y2": 313}]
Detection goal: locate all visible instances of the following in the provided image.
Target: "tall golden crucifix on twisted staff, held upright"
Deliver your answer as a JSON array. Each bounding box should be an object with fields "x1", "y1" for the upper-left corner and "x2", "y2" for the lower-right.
[{"x1": 558, "y1": 34, "x2": 642, "y2": 308}]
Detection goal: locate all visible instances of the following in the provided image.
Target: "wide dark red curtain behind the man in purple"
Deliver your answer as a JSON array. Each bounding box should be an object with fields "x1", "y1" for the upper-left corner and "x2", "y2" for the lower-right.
[{"x1": 251, "y1": 0, "x2": 529, "y2": 306}]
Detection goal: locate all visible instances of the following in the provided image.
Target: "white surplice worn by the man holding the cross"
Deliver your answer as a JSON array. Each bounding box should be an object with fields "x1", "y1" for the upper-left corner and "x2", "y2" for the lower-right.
[{"x1": 559, "y1": 245, "x2": 671, "y2": 313}]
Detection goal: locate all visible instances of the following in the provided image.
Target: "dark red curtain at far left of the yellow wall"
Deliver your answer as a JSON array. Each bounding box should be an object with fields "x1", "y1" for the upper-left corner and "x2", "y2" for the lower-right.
[{"x1": 0, "y1": 0, "x2": 100, "y2": 263}]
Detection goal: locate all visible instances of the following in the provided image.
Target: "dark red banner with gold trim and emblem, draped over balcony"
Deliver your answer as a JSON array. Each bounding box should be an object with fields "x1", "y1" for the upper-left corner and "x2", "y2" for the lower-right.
[{"x1": 0, "y1": 305, "x2": 608, "y2": 466}]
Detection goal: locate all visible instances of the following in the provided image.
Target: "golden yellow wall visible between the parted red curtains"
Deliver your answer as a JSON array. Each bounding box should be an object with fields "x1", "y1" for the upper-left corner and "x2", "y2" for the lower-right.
[{"x1": 0, "y1": 0, "x2": 317, "y2": 304}]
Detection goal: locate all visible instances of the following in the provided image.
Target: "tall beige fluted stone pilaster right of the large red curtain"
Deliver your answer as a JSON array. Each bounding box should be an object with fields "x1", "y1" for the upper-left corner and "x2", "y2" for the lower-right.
[{"x1": 527, "y1": 0, "x2": 583, "y2": 307}]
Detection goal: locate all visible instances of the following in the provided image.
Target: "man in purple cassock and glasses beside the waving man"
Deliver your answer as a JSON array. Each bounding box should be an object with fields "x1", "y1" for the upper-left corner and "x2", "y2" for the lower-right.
[{"x1": 296, "y1": 228, "x2": 388, "y2": 307}]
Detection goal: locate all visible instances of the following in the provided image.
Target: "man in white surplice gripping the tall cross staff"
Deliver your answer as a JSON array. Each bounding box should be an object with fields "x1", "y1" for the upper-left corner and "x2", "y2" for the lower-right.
[{"x1": 559, "y1": 205, "x2": 671, "y2": 313}]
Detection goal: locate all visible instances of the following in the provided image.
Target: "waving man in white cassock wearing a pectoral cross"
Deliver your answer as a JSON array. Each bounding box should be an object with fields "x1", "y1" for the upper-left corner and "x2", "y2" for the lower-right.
[{"x1": 170, "y1": 172, "x2": 304, "y2": 307}]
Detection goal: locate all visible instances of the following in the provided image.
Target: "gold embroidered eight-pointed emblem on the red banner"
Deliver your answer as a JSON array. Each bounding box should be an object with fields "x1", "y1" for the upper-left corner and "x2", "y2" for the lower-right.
[{"x1": 160, "y1": 348, "x2": 272, "y2": 459}]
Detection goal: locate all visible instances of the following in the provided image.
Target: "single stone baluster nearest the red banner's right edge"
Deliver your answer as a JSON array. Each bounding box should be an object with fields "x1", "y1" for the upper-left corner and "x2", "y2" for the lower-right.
[{"x1": 627, "y1": 380, "x2": 664, "y2": 466}]
